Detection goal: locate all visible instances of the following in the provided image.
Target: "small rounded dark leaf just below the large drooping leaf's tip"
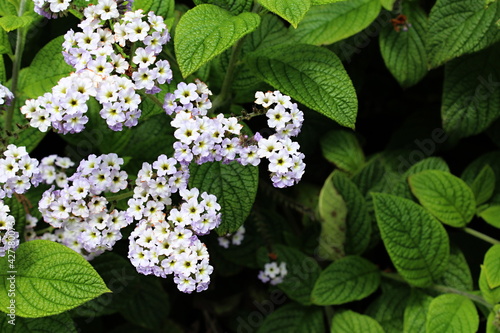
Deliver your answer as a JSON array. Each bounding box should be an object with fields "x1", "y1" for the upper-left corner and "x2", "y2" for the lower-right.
[{"x1": 320, "y1": 129, "x2": 365, "y2": 174}]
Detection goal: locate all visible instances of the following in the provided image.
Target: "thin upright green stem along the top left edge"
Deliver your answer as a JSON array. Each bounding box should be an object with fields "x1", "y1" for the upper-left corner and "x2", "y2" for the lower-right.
[{"x1": 5, "y1": 0, "x2": 27, "y2": 132}]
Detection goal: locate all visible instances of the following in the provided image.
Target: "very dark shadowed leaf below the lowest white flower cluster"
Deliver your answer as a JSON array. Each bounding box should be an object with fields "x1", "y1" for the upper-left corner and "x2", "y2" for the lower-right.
[{"x1": 120, "y1": 275, "x2": 170, "y2": 332}]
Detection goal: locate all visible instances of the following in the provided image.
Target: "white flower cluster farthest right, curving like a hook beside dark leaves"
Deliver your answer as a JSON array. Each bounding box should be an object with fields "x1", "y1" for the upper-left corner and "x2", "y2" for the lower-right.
[{"x1": 163, "y1": 81, "x2": 305, "y2": 188}]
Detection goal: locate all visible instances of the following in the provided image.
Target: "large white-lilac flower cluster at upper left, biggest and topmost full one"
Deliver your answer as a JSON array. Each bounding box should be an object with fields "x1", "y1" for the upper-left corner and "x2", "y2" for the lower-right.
[{"x1": 21, "y1": 1, "x2": 172, "y2": 134}]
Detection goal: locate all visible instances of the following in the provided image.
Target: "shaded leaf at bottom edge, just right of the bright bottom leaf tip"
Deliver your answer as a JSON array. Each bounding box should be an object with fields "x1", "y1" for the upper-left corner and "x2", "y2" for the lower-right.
[{"x1": 366, "y1": 284, "x2": 410, "y2": 333}]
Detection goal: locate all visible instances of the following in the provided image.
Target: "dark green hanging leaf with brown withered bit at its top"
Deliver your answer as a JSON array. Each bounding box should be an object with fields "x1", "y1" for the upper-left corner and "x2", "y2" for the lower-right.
[{"x1": 379, "y1": 2, "x2": 427, "y2": 88}]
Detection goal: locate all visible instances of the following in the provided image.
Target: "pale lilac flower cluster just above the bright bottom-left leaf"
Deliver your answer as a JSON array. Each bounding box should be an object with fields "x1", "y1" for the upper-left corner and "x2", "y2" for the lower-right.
[{"x1": 38, "y1": 154, "x2": 132, "y2": 258}]
